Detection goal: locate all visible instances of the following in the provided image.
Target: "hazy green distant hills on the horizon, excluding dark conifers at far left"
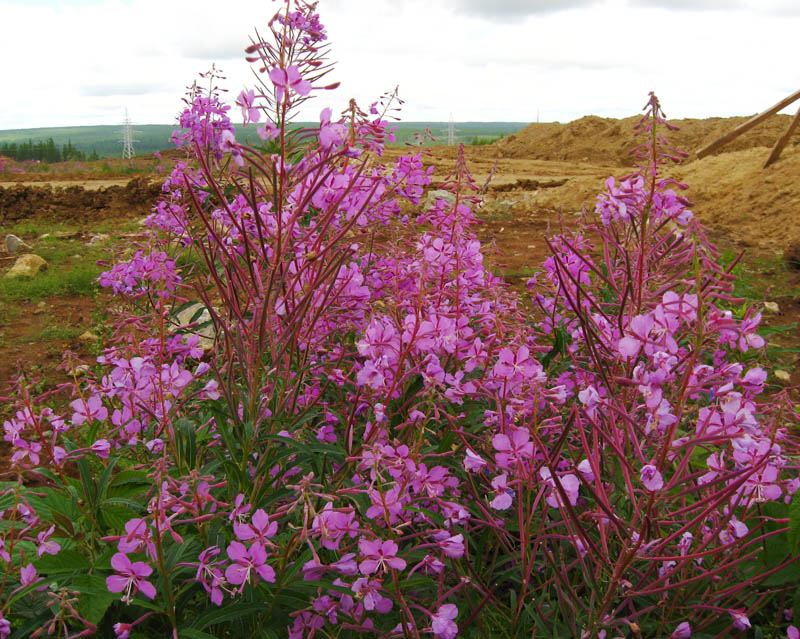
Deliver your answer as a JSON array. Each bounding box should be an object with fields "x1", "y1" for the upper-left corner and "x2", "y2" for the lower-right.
[{"x1": 0, "y1": 122, "x2": 528, "y2": 158}]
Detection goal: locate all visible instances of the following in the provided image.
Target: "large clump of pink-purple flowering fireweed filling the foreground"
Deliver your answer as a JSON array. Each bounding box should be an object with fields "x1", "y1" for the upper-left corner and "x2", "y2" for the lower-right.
[{"x1": 0, "y1": 2, "x2": 800, "y2": 639}]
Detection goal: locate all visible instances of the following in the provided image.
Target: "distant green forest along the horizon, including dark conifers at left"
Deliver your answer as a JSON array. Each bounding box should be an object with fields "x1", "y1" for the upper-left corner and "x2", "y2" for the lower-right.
[{"x1": 0, "y1": 122, "x2": 528, "y2": 162}]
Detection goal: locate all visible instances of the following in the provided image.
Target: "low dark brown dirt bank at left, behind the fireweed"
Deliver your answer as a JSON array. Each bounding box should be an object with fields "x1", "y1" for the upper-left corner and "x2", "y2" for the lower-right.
[{"x1": 0, "y1": 177, "x2": 161, "y2": 224}]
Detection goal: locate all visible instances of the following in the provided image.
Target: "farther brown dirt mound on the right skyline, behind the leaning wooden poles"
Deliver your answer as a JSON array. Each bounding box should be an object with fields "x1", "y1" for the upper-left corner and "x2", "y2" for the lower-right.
[{"x1": 493, "y1": 115, "x2": 800, "y2": 166}]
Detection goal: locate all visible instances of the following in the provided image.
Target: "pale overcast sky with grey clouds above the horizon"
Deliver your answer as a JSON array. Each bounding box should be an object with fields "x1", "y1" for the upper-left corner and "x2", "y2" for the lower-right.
[{"x1": 0, "y1": 0, "x2": 800, "y2": 129}]
